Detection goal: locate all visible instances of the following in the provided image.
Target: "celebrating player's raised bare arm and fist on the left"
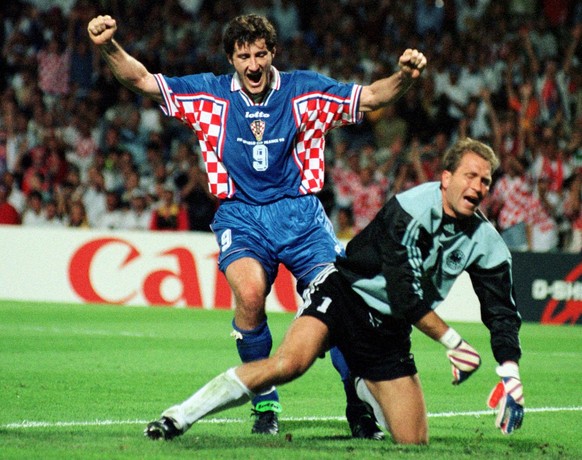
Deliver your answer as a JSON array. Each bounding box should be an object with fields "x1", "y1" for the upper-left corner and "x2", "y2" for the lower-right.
[{"x1": 87, "y1": 15, "x2": 162, "y2": 102}]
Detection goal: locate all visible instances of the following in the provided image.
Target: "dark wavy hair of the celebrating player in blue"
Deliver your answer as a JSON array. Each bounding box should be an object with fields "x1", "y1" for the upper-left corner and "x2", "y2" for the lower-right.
[{"x1": 222, "y1": 14, "x2": 277, "y2": 57}]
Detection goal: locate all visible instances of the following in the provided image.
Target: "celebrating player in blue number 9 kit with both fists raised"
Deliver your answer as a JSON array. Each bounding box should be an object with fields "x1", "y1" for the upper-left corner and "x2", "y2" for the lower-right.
[{"x1": 88, "y1": 15, "x2": 426, "y2": 439}]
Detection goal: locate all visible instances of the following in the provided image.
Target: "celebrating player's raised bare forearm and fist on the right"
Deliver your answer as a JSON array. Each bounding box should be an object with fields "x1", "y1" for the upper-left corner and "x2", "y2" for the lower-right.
[{"x1": 359, "y1": 48, "x2": 426, "y2": 112}]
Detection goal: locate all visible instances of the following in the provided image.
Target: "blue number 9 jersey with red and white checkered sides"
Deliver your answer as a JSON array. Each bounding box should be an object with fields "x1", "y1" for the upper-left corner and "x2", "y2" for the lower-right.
[{"x1": 155, "y1": 68, "x2": 362, "y2": 204}]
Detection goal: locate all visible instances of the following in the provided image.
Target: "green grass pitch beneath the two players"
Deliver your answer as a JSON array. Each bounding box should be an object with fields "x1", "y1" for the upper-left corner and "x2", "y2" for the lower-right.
[{"x1": 0, "y1": 301, "x2": 582, "y2": 460}]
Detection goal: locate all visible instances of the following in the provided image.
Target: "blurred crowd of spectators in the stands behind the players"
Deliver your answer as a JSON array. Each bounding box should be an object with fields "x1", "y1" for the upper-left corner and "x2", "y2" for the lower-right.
[{"x1": 0, "y1": 0, "x2": 582, "y2": 253}]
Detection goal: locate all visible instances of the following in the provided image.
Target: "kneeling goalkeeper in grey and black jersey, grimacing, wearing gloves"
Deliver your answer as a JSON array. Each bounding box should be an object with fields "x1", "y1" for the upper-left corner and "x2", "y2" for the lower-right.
[{"x1": 145, "y1": 138, "x2": 524, "y2": 444}]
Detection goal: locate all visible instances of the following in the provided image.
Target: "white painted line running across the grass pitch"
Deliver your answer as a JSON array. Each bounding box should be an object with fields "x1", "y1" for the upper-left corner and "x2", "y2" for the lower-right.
[{"x1": 0, "y1": 406, "x2": 582, "y2": 429}]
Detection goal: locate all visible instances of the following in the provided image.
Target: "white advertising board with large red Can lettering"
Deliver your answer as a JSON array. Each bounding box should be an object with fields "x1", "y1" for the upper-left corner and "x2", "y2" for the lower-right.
[{"x1": 0, "y1": 225, "x2": 299, "y2": 311}]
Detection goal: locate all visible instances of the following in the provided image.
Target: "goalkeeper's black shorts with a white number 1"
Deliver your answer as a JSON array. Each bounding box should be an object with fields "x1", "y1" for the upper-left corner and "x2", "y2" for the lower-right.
[{"x1": 299, "y1": 272, "x2": 417, "y2": 381}]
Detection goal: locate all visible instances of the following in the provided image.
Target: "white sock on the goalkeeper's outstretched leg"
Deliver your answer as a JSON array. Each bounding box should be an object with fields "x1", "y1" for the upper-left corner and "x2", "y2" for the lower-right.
[{"x1": 162, "y1": 367, "x2": 254, "y2": 432}]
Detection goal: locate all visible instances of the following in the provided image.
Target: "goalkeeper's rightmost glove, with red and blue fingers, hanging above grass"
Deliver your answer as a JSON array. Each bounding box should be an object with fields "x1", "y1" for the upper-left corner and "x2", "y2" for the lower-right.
[{"x1": 487, "y1": 361, "x2": 525, "y2": 434}]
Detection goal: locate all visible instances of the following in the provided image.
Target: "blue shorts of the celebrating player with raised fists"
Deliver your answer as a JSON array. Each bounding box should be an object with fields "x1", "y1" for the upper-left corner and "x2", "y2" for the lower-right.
[{"x1": 211, "y1": 195, "x2": 345, "y2": 292}]
